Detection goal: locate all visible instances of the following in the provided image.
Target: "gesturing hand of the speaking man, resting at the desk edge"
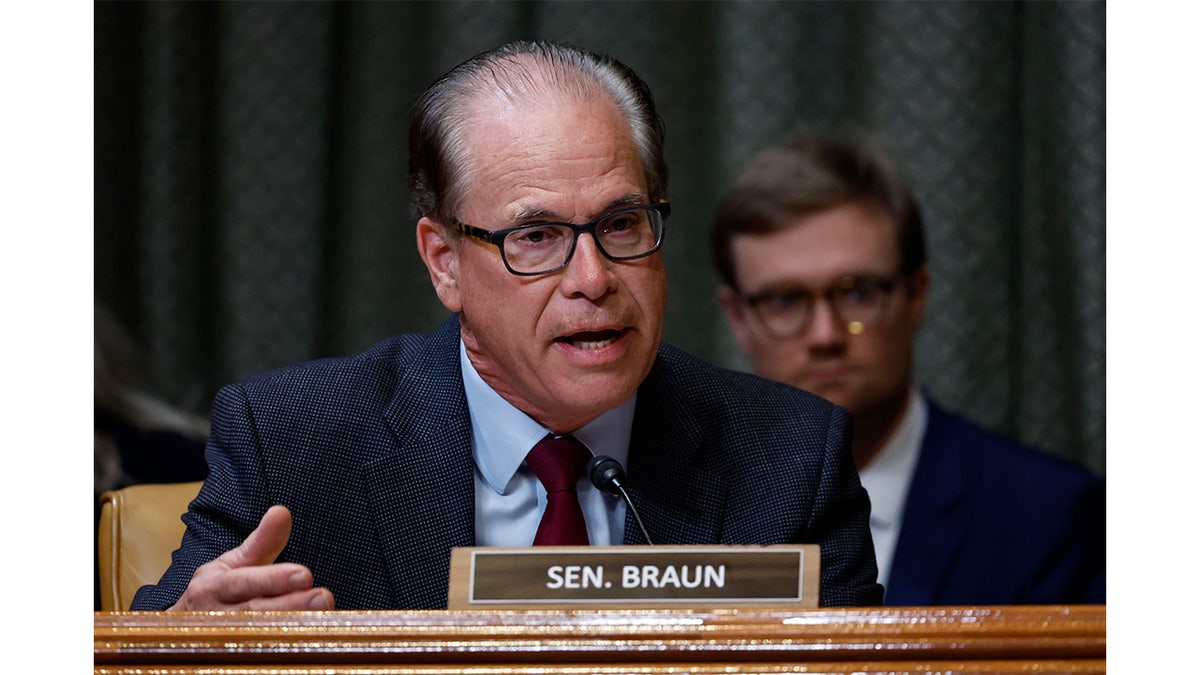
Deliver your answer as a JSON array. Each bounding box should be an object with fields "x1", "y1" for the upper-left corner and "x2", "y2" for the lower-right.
[{"x1": 170, "y1": 506, "x2": 334, "y2": 610}]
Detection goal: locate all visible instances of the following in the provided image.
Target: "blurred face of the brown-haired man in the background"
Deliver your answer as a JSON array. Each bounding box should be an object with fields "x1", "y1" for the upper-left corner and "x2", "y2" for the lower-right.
[{"x1": 721, "y1": 203, "x2": 928, "y2": 419}]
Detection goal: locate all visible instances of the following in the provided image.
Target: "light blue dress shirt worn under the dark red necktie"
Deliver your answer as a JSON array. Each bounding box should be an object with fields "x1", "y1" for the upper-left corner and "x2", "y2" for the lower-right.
[{"x1": 458, "y1": 340, "x2": 637, "y2": 546}]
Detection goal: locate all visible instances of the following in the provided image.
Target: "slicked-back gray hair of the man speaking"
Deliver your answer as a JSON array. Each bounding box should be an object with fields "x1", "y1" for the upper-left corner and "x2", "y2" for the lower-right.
[{"x1": 408, "y1": 41, "x2": 667, "y2": 222}]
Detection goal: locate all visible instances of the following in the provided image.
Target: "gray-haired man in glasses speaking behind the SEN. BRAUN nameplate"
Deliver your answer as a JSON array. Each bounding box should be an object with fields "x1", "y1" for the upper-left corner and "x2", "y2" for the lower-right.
[{"x1": 133, "y1": 42, "x2": 882, "y2": 609}]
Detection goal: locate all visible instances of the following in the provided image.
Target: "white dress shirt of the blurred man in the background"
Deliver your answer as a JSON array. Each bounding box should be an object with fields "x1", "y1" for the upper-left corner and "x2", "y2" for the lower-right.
[{"x1": 858, "y1": 389, "x2": 929, "y2": 595}]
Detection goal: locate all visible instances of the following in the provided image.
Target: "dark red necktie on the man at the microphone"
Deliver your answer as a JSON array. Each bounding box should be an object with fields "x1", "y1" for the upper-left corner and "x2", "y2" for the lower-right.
[{"x1": 526, "y1": 436, "x2": 592, "y2": 546}]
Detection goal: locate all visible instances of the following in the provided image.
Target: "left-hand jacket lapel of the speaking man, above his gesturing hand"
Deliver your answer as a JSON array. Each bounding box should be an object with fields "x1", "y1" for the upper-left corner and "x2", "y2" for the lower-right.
[{"x1": 364, "y1": 317, "x2": 475, "y2": 609}]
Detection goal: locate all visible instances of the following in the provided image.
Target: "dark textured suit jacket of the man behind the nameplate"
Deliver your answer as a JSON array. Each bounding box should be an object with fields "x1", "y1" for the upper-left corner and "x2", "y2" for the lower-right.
[{"x1": 133, "y1": 317, "x2": 882, "y2": 609}]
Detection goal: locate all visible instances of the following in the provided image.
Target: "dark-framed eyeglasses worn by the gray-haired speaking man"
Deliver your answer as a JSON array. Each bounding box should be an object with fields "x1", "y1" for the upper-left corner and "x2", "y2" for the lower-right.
[{"x1": 454, "y1": 202, "x2": 671, "y2": 276}]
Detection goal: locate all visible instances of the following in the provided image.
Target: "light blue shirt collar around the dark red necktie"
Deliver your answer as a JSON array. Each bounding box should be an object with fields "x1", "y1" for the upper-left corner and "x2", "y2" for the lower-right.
[{"x1": 458, "y1": 339, "x2": 637, "y2": 495}]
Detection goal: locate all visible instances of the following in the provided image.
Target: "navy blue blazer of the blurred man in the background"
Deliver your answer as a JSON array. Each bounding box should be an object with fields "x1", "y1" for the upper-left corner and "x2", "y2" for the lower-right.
[{"x1": 884, "y1": 401, "x2": 1105, "y2": 605}]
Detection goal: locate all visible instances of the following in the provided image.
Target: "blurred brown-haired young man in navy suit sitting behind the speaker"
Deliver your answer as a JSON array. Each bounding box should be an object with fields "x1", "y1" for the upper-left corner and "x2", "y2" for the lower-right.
[{"x1": 712, "y1": 135, "x2": 1105, "y2": 605}]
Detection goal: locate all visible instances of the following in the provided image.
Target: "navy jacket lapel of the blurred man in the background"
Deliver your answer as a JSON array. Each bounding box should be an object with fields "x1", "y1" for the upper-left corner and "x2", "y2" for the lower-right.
[{"x1": 886, "y1": 401, "x2": 967, "y2": 605}]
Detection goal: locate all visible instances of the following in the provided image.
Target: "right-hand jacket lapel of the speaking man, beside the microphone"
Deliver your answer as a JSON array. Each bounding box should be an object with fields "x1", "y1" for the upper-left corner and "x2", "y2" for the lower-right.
[{"x1": 624, "y1": 348, "x2": 728, "y2": 544}]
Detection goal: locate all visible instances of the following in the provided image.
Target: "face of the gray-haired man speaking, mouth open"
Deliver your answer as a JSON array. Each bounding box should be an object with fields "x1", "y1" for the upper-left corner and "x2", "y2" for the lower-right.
[{"x1": 418, "y1": 90, "x2": 667, "y2": 432}]
